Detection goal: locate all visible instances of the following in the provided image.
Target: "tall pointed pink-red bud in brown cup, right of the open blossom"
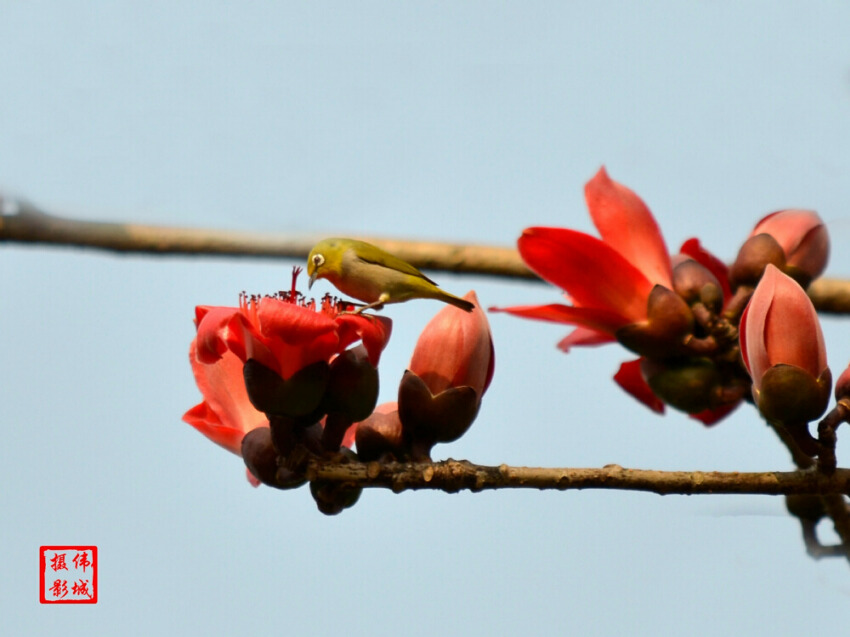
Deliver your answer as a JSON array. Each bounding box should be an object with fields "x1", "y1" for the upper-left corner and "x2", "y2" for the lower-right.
[{"x1": 739, "y1": 264, "x2": 831, "y2": 422}]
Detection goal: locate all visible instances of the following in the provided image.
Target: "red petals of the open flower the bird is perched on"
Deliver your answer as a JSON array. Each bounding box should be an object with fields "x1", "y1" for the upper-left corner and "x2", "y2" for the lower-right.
[{"x1": 183, "y1": 293, "x2": 392, "y2": 474}]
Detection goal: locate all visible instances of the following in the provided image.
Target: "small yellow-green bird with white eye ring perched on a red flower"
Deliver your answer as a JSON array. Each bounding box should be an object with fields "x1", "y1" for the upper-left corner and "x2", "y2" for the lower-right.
[{"x1": 307, "y1": 239, "x2": 475, "y2": 314}]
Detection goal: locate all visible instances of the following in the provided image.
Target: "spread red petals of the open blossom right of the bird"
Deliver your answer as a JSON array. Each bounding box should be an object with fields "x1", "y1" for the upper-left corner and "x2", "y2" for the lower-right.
[{"x1": 494, "y1": 168, "x2": 672, "y2": 351}]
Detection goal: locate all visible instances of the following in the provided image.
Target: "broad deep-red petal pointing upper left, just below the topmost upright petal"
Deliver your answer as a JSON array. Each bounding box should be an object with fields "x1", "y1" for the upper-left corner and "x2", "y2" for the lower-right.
[{"x1": 517, "y1": 228, "x2": 653, "y2": 324}]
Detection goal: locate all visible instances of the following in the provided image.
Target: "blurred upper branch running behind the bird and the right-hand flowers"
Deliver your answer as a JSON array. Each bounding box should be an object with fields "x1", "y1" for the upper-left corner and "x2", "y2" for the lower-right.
[{"x1": 0, "y1": 198, "x2": 850, "y2": 314}]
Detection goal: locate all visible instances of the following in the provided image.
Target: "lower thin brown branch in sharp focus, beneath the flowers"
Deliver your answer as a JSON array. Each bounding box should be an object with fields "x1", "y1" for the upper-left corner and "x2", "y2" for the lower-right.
[{"x1": 307, "y1": 460, "x2": 850, "y2": 495}]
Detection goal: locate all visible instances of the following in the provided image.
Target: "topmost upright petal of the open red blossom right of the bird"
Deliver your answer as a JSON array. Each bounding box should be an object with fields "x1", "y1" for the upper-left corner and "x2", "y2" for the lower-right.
[{"x1": 584, "y1": 166, "x2": 673, "y2": 289}]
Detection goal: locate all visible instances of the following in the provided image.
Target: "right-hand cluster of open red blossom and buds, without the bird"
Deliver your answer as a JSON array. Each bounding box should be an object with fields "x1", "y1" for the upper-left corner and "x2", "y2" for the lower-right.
[{"x1": 494, "y1": 168, "x2": 830, "y2": 425}]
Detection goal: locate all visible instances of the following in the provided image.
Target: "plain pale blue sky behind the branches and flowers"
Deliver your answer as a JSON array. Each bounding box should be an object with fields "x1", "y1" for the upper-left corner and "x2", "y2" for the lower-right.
[{"x1": 0, "y1": 1, "x2": 850, "y2": 636}]
